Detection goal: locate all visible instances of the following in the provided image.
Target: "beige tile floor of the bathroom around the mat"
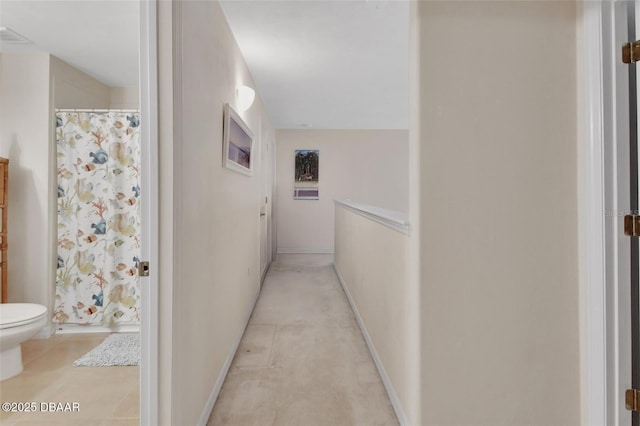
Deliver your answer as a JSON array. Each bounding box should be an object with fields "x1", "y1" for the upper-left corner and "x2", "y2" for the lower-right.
[{"x1": 0, "y1": 334, "x2": 140, "y2": 426}]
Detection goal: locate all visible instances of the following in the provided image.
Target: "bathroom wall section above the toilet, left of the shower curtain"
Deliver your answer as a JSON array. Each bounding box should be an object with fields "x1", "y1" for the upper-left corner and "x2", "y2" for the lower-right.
[{"x1": 0, "y1": 53, "x2": 55, "y2": 308}]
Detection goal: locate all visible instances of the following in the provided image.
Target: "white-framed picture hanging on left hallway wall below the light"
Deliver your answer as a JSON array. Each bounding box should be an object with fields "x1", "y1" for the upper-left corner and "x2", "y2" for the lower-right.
[{"x1": 222, "y1": 103, "x2": 254, "y2": 176}]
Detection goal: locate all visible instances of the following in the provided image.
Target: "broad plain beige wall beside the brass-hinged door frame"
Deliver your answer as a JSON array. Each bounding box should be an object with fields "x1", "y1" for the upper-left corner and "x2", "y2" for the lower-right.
[{"x1": 412, "y1": 1, "x2": 580, "y2": 426}]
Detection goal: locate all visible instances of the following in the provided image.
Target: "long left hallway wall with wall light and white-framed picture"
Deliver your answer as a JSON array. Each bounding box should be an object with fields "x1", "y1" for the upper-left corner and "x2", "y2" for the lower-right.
[{"x1": 159, "y1": 1, "x2": 274, "y2": 425}]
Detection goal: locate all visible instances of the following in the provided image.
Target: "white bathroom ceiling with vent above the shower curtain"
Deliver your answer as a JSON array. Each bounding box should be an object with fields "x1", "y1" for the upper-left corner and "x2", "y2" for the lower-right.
[{"x1": 0, "y1": 0, "x2": 139, "y2": 87}]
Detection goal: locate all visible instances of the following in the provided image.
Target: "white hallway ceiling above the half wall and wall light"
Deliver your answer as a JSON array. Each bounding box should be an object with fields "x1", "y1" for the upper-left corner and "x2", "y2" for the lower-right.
[{"x1": 221, "y1": 0, "x2": 409, "y2": 129}]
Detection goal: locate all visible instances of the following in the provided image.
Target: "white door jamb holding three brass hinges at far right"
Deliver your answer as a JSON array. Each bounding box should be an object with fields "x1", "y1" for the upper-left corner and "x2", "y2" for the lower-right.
[{"x1": 605, "y1": 1, "x2": 631, "y2": 426}]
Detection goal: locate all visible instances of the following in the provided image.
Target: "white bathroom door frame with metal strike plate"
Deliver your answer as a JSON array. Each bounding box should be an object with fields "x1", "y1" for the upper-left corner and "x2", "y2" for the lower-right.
[{"x1": 138, "y1": 0, "x2": 159, "y2": 425}]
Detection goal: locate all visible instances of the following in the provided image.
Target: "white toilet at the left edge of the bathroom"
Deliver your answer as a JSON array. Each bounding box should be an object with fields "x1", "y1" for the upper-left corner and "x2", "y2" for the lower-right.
[{"x1": 0, "y1": 303, "x2": 47, "y2": 381}]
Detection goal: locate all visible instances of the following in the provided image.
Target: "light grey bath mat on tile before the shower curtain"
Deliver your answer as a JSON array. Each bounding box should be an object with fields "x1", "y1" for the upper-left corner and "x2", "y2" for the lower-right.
[{"x1": 73, "y1": 333, "x2": 140, "y2": 367}]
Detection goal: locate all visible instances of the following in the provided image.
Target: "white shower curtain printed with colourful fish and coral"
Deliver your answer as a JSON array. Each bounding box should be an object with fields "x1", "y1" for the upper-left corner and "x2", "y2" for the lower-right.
[{"x1": 53, "y1": 111, "x2": 140, "y2": 326}]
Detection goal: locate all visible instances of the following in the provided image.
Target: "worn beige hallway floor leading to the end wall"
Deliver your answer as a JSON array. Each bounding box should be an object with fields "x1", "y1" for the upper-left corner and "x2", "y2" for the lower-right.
[{"x1": 208, "y1": 254, "x2": 398, "y2": 426}]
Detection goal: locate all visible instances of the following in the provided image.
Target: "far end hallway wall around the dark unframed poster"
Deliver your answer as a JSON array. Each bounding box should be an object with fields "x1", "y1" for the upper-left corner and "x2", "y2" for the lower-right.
[{"x1": 276, "y1": 130, "x2": 409, "y2": 252}]
